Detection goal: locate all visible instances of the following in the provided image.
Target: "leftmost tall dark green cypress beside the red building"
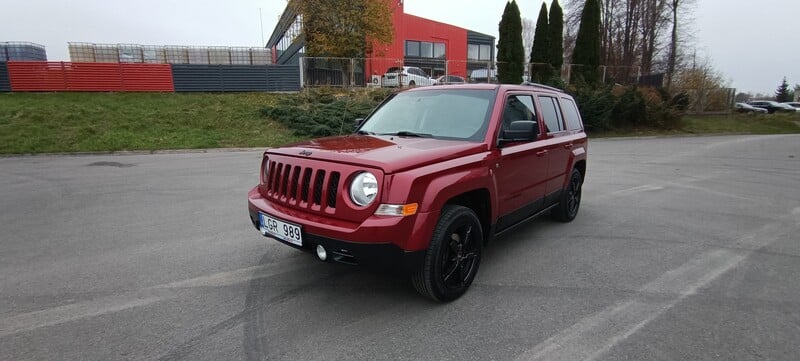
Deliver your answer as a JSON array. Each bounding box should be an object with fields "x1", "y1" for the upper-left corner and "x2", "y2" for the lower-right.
[{"x1": 497, "y1": 0, "x2": 525, "y2": 84}]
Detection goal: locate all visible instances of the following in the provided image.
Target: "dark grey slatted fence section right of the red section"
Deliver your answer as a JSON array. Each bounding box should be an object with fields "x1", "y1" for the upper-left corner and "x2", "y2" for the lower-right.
[{"x1": 172, "y1": 64, "x2": 300, "y2": 92}]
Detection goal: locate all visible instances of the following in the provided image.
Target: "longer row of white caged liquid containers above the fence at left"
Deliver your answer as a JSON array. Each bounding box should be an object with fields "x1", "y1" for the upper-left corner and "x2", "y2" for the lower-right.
[{"x1": 69, "y1": 43, "x2": 272, "y2": 65}]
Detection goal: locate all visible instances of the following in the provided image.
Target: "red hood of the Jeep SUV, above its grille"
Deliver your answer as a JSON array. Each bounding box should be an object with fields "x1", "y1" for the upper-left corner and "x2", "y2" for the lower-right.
[{"x1": 267, "y1": 135, "x2": 486, "y2": 174}]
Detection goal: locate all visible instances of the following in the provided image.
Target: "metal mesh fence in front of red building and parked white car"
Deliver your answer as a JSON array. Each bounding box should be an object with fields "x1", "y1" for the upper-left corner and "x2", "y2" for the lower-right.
[{"x1": 300, "y1": 57, "x2": 648, "y2": 87}]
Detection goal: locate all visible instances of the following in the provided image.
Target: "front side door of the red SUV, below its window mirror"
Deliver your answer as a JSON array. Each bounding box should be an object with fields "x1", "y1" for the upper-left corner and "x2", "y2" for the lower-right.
[{"x1": 493, "y1": 93, "x2": 547, "y2": 231}]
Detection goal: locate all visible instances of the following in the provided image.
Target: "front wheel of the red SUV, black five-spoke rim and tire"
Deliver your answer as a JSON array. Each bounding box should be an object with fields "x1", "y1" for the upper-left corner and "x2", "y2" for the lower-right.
[{"x1": 411, "y1": 205, "x2": 483, "y2": 302}]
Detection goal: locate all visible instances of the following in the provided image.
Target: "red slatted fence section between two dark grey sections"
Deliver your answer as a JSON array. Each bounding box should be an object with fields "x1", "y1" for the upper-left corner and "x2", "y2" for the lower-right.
[{"x1": 8, "y1": 61, "x2": 175, "y2": 92}]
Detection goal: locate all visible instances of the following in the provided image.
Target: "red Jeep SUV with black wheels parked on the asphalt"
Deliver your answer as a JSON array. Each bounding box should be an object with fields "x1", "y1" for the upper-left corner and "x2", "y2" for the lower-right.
[{"x1": 248, "y1": 83, "x2": 588, "y2": 301}]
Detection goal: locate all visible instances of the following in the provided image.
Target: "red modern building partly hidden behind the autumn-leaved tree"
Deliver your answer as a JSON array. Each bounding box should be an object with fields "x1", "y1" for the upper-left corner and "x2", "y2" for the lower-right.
[{"x1": 266, "y1": 0, "x2": 495, "y2": 82}]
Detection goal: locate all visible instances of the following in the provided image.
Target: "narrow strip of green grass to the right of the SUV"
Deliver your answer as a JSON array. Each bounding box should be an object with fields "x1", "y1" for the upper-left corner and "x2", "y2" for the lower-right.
[{"x1": 591, "y1": 114, "x2": 800, "y2": 137}]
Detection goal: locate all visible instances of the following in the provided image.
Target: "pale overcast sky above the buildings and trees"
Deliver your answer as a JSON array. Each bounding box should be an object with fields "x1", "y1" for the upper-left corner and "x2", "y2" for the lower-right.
[{"x1": 0, "y1": 0, "x2": 800, "y2": 93}]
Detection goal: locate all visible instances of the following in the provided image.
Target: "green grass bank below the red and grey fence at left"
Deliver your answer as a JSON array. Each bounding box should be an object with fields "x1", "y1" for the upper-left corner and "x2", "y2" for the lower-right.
[{"x1": 0, "y1": 93, "x2": 300, "y2": 154}]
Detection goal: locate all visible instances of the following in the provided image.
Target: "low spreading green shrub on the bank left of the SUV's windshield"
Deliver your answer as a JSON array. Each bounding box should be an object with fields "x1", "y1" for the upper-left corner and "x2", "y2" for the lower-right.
[{"x1": 261, "y1": 88, "x2": 392, "y2": 137}]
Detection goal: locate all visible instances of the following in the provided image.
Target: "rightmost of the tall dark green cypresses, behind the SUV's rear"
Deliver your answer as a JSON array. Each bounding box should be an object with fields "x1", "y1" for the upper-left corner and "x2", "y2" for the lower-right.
[{"x1": 572, "y1": 0, "x2": 600, "y2": 84}]
